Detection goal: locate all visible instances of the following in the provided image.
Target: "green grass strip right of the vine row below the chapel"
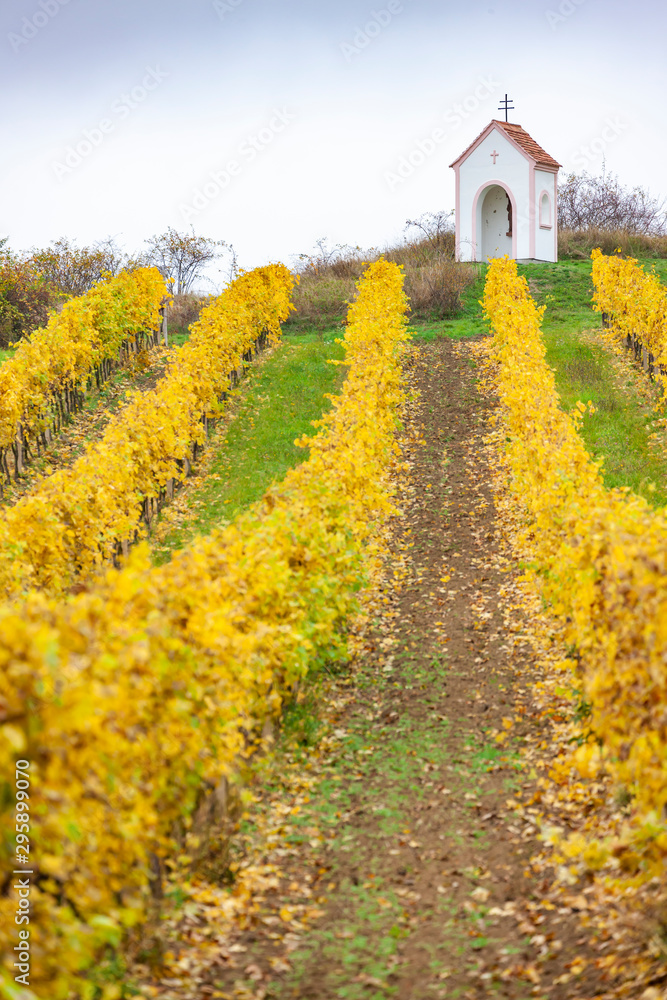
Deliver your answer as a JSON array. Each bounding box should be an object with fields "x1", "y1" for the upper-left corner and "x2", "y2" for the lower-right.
[{"x1": 519, "y1": 261, "x2": 667, "y2": 506}]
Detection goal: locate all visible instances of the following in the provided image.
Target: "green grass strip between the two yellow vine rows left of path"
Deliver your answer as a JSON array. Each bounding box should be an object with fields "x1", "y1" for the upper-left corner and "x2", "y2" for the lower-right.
[{"x1": 154, "y1": 328, "x2": 346, "y2": 563}]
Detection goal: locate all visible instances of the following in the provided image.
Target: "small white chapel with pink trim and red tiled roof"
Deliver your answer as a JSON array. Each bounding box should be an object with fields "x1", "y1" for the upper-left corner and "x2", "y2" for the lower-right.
[{"x1": 450, "y1": 119, "x2": 561, "y2": 261}]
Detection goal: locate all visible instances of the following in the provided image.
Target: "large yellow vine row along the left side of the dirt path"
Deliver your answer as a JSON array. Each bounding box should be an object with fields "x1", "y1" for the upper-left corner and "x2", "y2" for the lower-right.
[{"x1": 0, "y1": 261, "x2": 407, "y2": 1000}]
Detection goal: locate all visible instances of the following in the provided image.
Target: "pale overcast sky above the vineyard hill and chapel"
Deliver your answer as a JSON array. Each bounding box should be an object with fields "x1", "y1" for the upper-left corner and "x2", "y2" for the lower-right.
[{"x1": 0, "y1": 0, "x2": 667, "y2": 288}]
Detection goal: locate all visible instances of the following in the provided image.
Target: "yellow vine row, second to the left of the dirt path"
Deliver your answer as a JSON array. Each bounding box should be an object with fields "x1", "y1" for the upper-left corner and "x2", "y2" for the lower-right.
[{"x1": 0, "y1": 264, "x2": 293, "y2": 598}]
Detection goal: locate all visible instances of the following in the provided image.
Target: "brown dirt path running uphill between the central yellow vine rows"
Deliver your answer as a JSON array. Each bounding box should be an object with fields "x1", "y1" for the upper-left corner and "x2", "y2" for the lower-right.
[{"x1": 137, "y1": 342, "x2": 610, "y2": 1000}]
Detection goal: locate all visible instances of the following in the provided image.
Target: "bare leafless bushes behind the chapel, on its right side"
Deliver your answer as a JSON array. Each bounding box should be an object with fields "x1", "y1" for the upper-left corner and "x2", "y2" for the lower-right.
[{"x1": 558, "y1": 171, "x2": 667, "y2": 236}]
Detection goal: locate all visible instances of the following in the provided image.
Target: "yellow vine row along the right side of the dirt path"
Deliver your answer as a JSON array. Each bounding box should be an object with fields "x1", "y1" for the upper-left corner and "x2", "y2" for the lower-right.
[{"x1": 484, "y1": 258, "x2": 667, "y2": 879}]
